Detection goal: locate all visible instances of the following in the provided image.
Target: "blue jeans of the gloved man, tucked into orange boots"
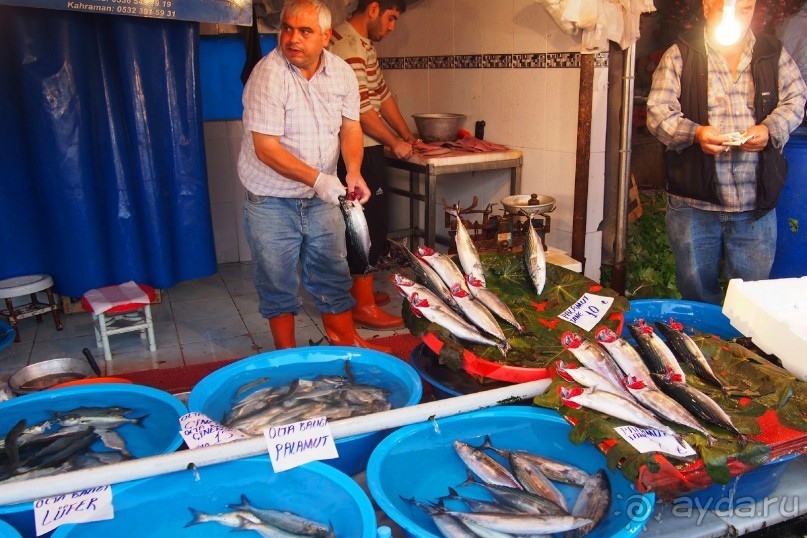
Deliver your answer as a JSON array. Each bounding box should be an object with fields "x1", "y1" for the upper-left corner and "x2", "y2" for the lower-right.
[{"x1": 244, "y1": 192, "x2": 356, "y2": 318}]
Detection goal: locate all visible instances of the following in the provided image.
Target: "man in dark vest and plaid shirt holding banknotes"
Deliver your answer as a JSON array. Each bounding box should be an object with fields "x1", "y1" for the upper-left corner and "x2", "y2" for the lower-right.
[{"x1": 647, "y1": 0, "x2": 807, "y2": 304}]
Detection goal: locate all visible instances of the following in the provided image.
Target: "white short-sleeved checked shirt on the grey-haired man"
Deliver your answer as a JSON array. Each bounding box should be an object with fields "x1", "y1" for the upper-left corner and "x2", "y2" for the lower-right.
[{"x1": 238, "y1": 46, "x2": 359, "y2": 198}]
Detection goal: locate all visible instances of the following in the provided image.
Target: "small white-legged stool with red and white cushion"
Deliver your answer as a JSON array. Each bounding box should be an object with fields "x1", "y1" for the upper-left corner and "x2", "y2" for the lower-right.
[{"x1": 81, "y1": 284, "x2": 157, "y2": 361}]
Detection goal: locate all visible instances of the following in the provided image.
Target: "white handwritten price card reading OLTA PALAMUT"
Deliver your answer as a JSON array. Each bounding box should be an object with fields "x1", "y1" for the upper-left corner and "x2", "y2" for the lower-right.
[{"x1": 263, "y1": 417, "x2": 339, "y2": 473}]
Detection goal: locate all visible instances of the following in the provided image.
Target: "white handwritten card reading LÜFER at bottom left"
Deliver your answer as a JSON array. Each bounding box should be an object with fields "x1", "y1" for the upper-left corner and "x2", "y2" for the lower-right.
[{"x1": 34, "y1": 486, "x2": 115, "y2": 536}]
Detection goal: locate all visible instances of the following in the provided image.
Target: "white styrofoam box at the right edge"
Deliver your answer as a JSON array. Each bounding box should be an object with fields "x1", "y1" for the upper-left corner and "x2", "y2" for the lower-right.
[{"x1": 723, "y1": 277, "x2": 807, "y2": 381}]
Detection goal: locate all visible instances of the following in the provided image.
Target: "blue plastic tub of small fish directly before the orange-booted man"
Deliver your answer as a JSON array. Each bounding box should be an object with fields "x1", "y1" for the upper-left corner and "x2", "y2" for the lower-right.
[{"x1": 188, "y1": 346, "x2": 423, "y2": 475}]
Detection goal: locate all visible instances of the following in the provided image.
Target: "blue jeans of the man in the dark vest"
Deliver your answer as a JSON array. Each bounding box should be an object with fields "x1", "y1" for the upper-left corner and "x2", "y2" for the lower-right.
[{"x1": 666, "y1": 197, "x2": 776, "y2": 304}]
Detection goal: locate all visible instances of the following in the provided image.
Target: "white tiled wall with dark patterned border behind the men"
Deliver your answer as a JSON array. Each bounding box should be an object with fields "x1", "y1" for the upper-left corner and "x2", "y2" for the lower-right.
[{"x1": 205, "y1": 0, "x2": 608, "y2": 279}]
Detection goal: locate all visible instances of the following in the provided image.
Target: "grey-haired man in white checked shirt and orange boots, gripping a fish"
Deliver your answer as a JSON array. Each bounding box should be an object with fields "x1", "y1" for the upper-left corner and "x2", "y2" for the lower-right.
[{"x1": 238, "y1": 0, "x2": 390, "y2": 353}]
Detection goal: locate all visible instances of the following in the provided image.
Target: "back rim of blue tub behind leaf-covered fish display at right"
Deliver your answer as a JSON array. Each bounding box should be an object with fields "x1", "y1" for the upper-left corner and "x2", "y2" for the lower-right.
[{"x1": 622, "y1": 299, "x2": 742, "y2": 340}]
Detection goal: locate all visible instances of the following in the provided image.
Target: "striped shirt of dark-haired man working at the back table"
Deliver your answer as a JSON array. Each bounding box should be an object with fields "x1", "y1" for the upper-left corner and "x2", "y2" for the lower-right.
[{"x1": 328, "y1": 21, "x2": 392, "y2": 147}]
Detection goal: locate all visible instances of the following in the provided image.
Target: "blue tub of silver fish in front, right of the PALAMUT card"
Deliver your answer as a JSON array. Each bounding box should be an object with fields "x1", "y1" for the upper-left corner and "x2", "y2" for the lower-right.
[{"x1": 367, "y1": 406, "x2": 655, "y2": 538}]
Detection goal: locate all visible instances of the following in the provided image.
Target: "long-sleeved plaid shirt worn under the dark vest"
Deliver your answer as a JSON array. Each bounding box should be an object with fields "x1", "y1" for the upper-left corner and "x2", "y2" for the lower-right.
[{"x1": 647, "y1": 31, "x2": 806, "y2": 212}]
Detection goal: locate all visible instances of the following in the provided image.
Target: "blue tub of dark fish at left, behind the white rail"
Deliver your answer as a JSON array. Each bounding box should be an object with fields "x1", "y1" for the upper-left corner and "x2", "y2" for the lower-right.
[{"x1": 0, "y1": 383, "x2": 187, "y2": 536}]
